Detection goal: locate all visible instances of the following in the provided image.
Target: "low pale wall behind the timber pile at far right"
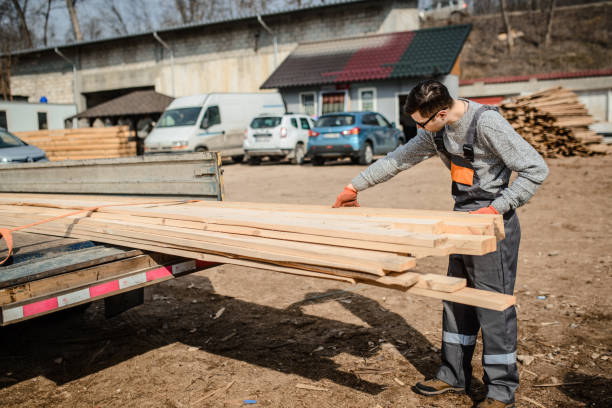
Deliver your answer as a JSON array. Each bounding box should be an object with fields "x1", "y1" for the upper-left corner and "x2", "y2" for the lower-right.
[{"x1": 459, "y1": 76, "x2": 612, "y2": 122}]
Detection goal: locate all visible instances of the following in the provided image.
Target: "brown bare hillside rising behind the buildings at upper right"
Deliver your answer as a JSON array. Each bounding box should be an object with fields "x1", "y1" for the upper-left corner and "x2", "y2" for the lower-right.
[{"x1": 423, "y1": 2, "x2": 612, "y2": 79}]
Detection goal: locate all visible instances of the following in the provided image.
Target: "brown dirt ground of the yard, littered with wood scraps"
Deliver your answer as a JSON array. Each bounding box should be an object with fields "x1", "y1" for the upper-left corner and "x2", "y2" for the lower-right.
[{"x1": 0, "y1": 157, "x2": 612, "y2": 408}]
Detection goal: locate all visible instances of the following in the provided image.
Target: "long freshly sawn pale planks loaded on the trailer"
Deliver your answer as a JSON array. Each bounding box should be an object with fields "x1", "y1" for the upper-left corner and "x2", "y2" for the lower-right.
[{"x1": 0, "y1": 194, "x2": 514, "y2": 310}]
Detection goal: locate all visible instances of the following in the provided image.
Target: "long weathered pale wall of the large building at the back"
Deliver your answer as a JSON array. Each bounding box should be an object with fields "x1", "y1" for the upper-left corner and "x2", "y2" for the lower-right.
[{"x1": 11, "y1": 0, "x2": 418, "y2": 111}]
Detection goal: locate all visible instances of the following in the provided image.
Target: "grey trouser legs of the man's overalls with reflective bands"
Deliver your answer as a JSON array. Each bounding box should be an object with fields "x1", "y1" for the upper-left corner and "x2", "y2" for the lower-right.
[{"x1": 437, "y1": 212, "x2": 521, "y2": 403}]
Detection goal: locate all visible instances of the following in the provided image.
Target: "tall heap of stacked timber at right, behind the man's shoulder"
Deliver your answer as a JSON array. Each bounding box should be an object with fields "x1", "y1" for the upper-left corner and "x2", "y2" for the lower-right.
[{"x1": 501, "y1": 87, "x2": 603, "y2": 158}]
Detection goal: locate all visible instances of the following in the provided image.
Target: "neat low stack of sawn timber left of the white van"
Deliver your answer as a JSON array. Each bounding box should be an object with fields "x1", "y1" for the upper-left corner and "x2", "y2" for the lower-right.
[{"x1": 15, "y1": 126, "x2": 136, "y2": 161}]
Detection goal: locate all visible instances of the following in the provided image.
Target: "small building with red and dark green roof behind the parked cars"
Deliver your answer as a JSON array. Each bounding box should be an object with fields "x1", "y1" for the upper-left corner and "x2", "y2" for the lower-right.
[{"x1": 262, "y1": 25, "x2": 471, "y2": 136}]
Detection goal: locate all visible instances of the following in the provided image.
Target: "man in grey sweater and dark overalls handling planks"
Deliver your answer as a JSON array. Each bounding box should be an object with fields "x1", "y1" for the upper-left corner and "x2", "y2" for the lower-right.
[{"x1": 334, "y1": 80, "x2": 548, "y2": 408}]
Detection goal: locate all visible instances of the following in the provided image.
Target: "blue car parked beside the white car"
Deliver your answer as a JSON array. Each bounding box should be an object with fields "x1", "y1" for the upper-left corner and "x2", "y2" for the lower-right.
[{"x1": 307, "y1": 112, "x2": 404, "y2": 166}]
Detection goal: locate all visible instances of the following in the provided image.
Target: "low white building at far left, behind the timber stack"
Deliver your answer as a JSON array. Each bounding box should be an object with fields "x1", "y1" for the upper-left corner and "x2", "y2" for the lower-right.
[{"x1": 0, "y1": 101, "x2": 76, "y2": 132}]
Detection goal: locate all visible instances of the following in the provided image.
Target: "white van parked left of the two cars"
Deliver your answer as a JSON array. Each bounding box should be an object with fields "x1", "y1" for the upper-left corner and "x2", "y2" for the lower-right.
[{"x1": 144, "y1": 93, "x2": 285, "y2": 162}]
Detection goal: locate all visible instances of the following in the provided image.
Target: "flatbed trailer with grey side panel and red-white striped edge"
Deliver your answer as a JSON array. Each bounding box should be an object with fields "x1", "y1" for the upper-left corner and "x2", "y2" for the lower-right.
[{"x1": 0, "y1": 152, "x2": 223, "y2": 326}]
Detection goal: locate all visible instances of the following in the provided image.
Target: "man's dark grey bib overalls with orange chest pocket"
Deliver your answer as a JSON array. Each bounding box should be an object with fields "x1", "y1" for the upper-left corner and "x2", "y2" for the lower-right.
[{"x1": 434, "y1": 106, "x2": 521, "y2": 403}]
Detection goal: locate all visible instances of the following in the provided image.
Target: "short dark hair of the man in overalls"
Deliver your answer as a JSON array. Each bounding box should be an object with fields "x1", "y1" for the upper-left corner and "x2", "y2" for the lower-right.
[{"x1": 404, "y1": 79, "x2": 453, "y2": 117}]
